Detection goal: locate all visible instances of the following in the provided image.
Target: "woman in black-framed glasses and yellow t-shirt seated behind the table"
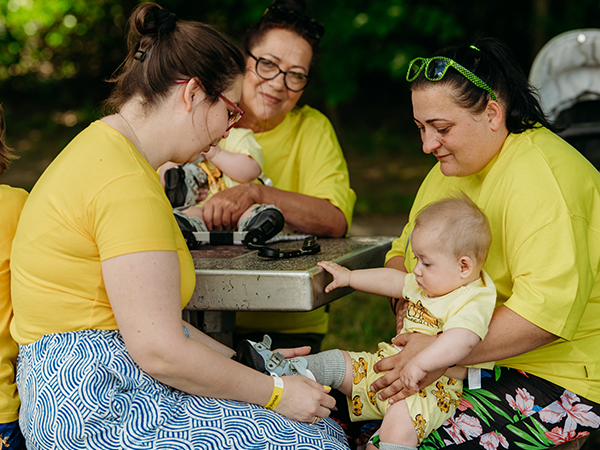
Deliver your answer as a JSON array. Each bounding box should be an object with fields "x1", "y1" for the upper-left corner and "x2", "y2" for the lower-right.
[{"x1": 203, "y1": 0, "x2": 356, "y2": 352}]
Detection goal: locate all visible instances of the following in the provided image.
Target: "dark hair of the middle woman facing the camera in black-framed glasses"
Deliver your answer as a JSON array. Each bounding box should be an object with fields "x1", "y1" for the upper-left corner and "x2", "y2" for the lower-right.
[{"x1": 243, "y1": 0, "x2": 325, "y2": 68}]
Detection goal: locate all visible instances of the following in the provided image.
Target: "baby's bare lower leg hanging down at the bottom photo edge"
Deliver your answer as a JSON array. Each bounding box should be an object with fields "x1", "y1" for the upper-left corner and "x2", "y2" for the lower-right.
[{"x1": 373, "y1": 400, "x2": 419, "y2": 450}]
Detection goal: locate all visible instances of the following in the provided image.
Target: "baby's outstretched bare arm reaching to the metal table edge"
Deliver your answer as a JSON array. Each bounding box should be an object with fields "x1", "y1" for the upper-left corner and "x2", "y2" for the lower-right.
[{"x1": 317, "y1": 261, "x2": 406, "y2": 297}]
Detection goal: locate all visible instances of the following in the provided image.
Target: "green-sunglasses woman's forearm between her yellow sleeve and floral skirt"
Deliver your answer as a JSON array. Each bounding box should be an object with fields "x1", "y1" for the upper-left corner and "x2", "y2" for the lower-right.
[{"x1": 460, "y1": 306, "x2": 558, "y2": 365}]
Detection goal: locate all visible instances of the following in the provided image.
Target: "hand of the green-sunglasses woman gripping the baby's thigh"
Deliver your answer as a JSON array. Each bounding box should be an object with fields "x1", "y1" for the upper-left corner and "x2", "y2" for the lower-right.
[{"x1": 371, "y1": 333, "x2": 436, "y2": 402}]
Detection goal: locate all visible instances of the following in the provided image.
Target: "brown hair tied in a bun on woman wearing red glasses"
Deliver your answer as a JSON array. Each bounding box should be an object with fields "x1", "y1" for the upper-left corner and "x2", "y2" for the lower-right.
[{"x1": 104, "y1": 2, "x2": 246, "y2": 112}]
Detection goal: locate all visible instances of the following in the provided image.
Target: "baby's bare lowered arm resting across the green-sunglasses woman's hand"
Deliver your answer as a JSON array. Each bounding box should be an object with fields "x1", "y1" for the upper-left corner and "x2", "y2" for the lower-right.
[{"x1": 400, "y1": 328, "x2": 481, "y2": 392}]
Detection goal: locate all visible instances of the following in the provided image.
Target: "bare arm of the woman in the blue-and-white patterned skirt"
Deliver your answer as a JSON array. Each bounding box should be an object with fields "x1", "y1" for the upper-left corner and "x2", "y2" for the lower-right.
[{"x1": 102, "y1": 251, "x2": 273, "y2": 404}]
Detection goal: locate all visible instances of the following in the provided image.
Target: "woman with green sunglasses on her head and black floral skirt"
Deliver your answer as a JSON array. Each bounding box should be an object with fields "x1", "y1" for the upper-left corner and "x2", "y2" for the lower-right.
[{"x1": 372, "y1": 39, "x2": 600, "y2": 448}]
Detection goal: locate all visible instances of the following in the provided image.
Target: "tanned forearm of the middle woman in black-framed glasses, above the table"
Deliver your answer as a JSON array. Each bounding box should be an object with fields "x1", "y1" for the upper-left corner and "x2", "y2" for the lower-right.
[{"x1": 253, "y1": 185, "x2": 348, "y2": 237}]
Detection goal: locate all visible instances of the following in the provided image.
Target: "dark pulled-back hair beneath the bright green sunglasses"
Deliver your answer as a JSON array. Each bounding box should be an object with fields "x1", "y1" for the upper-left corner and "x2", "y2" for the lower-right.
[{"x1": 411, "y1": 38, "x2": 556, "y2": 133}]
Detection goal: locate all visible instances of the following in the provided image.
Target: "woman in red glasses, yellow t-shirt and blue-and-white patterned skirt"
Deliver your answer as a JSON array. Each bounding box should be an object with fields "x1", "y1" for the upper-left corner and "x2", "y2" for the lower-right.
[{"x1": 11, "y1": 3, "x2": 346, "y2": 449}]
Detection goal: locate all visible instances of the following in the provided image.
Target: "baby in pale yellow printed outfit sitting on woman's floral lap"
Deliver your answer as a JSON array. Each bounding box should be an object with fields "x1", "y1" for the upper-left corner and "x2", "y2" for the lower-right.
[{"x1": 237, "y1": 194, "x2": 496, "y2": 450}]
